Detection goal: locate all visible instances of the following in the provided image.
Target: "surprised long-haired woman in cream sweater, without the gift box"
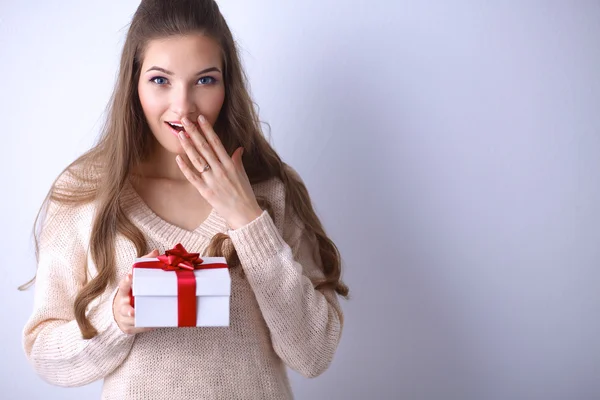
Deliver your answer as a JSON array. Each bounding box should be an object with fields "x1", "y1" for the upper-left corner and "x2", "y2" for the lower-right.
[{"x1": 24, "y1": 0, "x2": 348, "y2": 400}]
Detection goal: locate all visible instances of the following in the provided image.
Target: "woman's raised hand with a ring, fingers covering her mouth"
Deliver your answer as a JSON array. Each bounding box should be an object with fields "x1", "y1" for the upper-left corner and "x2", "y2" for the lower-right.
[{"x1": 171, "y1": 116, "x2": 263, "y2": 229}]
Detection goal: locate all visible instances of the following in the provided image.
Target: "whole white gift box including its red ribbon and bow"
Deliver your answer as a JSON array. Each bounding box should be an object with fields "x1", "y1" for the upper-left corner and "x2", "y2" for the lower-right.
[{"x1": 130, "y1": 244, "x2": 231, "y2": 328}]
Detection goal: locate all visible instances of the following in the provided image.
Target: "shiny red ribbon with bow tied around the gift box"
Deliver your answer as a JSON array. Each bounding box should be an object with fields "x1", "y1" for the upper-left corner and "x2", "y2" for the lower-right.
[{"x1": 129, "y1": 243, "x2": 227, "y2": 327}]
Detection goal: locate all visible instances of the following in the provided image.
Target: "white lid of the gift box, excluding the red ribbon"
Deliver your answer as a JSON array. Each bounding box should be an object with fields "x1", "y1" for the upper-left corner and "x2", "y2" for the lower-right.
[{"x1": 132, "y1": 257, "x2": 231, "y2": 297}]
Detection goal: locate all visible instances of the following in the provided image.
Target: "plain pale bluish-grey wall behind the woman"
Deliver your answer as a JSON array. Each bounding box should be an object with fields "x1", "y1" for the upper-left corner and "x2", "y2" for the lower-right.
[{"x1": 0, "y1": 0, "x2": 600, "y2": 400}]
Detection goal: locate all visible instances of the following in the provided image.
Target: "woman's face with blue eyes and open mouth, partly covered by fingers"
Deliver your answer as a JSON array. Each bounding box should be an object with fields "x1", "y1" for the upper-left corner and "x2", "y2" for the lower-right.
[{"x1": 138, "y1": 35, "x2": 225, "y2": 154}]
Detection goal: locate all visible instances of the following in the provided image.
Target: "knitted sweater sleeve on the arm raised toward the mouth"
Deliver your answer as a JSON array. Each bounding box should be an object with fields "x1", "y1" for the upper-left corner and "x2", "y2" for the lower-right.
[{"x1": 228, "y1": 180, "x2": 343, "y2": 378}]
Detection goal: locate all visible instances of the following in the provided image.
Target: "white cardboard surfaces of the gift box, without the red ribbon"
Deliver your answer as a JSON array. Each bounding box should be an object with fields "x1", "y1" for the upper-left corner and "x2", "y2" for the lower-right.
[{"x1": 132, "y1": 257, "x2": 231, "y2": 328}]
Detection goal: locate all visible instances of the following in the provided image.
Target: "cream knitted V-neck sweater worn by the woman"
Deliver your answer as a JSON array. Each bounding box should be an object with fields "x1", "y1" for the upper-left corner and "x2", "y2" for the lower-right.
[{"x1": 23, "y1": 173, "x2": 342, "y2": 400}]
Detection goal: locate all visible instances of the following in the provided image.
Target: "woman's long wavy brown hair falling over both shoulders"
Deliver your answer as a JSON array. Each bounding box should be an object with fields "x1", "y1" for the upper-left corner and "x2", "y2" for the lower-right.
[{"x1": 20, "y1": 0, "x2": 348, "y2": 339}]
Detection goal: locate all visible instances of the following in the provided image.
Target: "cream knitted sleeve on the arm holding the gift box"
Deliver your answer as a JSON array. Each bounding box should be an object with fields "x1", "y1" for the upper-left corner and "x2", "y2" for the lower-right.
[{"x1": 23, "y1": 198, "x2": 134, "y2": 386}]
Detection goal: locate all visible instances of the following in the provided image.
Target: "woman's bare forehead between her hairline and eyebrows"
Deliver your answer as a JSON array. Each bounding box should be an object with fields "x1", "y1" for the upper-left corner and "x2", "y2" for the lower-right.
[{"x1": 142, "y1": 34, "x2": 222, "y2": 74}]
